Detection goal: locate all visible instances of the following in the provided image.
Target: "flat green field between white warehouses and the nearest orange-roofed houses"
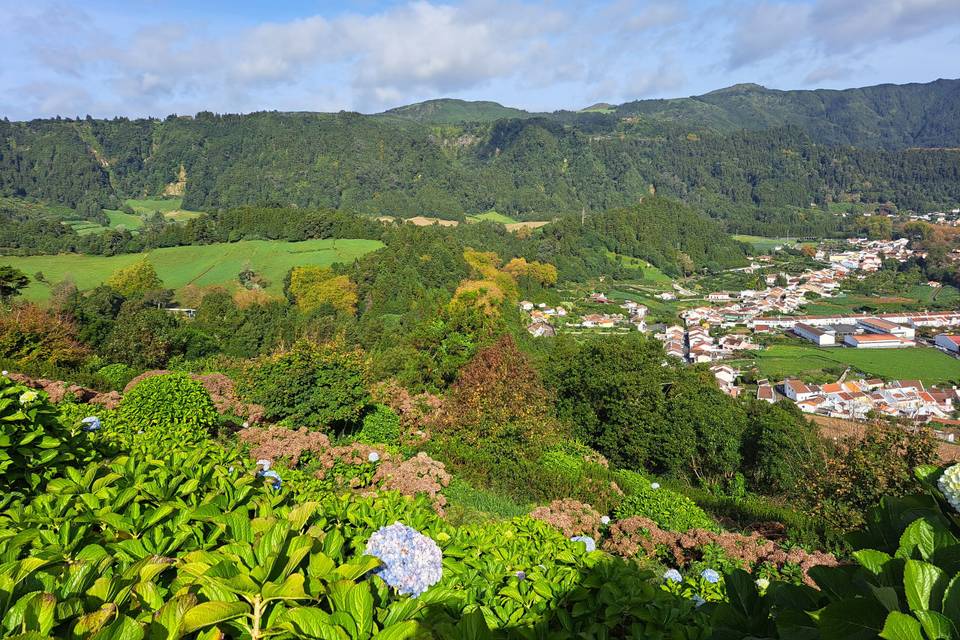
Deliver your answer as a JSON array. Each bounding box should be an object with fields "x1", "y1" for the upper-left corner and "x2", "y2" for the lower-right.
[{"x1": 755, "y1": 344, "x2": 960, "y2": 384}]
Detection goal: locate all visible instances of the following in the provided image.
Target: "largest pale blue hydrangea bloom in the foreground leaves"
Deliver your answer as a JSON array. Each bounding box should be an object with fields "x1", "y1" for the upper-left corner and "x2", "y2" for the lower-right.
[{"x1": 366, "y1": 522, "x2": 443, "y2": 597}]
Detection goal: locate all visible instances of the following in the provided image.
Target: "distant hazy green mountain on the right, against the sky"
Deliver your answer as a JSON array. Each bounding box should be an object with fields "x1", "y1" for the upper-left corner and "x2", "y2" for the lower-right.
[{"x1": 617, "y1": 80, "x2": 960, "y2": 148}]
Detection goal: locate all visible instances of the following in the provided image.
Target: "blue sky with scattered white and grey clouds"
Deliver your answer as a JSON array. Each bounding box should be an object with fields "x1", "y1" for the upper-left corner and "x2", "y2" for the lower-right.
[{"x1": 0, "y1": 0, "x2": 960, "y2": 120}]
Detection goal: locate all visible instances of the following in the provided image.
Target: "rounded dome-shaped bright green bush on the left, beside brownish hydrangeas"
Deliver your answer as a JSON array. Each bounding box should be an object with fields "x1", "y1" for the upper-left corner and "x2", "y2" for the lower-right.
[{"x1": 118, "y1": 373, "x2": 219, "y2": 441}]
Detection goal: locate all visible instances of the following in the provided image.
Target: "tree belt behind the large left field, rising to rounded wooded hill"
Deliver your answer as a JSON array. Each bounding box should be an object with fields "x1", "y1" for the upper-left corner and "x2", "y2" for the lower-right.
[{"x1": 0, "y1": 197, "x2": 744, "y2": 280}]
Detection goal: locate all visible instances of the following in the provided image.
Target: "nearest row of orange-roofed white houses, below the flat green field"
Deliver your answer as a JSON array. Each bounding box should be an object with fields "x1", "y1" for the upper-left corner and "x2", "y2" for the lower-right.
[{"x1": 776, "y1": 379, "x2": 960, "y2": 422}]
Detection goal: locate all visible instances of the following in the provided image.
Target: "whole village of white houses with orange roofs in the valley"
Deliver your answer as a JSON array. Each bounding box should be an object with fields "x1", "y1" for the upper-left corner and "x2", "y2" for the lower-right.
[{"x1": 521, "y1": 239, "x2": 960, "y2": 426}]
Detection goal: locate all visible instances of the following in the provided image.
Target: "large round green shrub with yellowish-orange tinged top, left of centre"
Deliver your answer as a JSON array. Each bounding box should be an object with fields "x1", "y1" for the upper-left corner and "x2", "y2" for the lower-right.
[{"x1": 240, "y1": 340, "x2": 370, "y2": 430}]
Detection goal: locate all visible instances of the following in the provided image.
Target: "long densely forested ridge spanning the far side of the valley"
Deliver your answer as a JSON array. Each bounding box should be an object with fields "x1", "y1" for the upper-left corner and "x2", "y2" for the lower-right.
[{"x1": 0, "y1": 113, "x2": 960, "y2": 235}]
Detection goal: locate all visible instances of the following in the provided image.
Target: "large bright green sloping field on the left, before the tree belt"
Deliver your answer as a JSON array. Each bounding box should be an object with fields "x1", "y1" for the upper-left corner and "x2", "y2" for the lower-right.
[{"x1": 0, "y1": 240, "x2": 383, "y2": 301}]
